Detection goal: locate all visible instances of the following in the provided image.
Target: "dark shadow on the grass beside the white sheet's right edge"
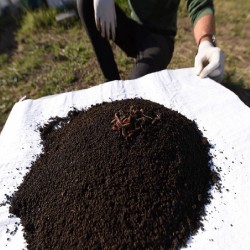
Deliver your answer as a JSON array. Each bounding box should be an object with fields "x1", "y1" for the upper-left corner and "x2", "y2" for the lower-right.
[{"x1": 222, "y1": 73, "x2": 250, "y2": 107}]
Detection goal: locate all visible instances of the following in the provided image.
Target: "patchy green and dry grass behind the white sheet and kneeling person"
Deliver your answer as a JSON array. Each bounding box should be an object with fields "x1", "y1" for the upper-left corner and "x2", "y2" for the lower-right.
[{"x1": 0, "y1": 0, "x2": 250, "y2": 131}]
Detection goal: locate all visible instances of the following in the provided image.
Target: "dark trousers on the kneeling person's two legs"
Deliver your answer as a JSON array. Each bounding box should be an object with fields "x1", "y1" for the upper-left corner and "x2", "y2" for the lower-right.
[{"x1": 77, "y1": 0, "x2": 174, "y2": 81}]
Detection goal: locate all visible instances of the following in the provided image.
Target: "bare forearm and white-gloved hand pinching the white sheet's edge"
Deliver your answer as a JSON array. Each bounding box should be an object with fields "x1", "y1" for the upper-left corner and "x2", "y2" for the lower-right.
[{"x1": 194, "y1": 13, "x2": 225, "y2": 82}]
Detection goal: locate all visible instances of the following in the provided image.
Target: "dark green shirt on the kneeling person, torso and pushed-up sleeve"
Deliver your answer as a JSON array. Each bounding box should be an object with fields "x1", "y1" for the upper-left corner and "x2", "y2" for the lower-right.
[{"x1": 128, "y1": 0, "x2": 214, "y2": 37}]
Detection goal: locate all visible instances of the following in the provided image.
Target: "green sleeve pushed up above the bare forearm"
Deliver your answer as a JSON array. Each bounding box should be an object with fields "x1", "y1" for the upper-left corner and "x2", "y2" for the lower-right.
[{"x1": 187, "y1": 0, "x2": 214, "y2": 25}]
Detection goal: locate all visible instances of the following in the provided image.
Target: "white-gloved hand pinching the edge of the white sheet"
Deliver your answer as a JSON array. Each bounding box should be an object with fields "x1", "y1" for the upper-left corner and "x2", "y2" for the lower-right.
[{"x1": 194, "y1": 41, "x2": 225, "y2": 82}]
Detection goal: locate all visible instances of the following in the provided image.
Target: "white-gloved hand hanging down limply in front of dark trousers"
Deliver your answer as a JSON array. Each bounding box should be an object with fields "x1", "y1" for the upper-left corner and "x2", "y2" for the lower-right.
[{"x1": 94, "y1": 0, "x2": 116, "y2": 40}]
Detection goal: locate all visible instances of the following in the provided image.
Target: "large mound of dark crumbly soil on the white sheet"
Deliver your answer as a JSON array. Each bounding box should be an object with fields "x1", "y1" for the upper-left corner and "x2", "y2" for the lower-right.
[{"x1": 10, "y1": 99, "x2": 217, "y2": 249}]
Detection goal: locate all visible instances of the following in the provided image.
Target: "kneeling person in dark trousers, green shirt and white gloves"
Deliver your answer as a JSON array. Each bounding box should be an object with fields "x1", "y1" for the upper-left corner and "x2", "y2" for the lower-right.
[{"x1": 77, "y1": 0, "x2": 224, "y2": 82}]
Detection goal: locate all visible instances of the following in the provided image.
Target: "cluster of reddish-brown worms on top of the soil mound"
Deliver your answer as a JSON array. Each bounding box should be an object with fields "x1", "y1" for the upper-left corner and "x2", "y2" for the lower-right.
[{"x1": 111, "y1": 106, "x2": 161, "y2": 139}]
